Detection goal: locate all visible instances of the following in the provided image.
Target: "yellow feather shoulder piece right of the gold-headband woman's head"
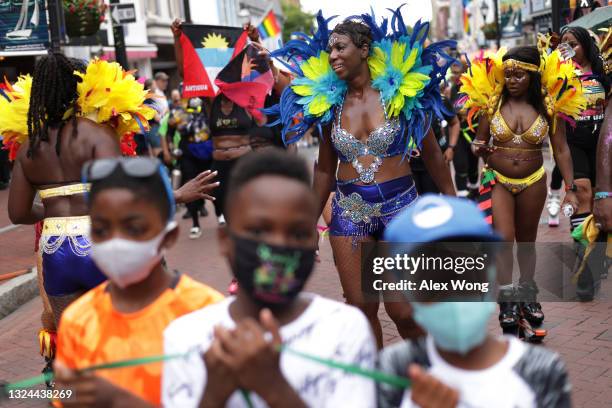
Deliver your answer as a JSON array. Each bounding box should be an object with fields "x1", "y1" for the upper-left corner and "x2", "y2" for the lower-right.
[{"x1": 540, "y1": 50, "x2": 586, "y2": 132}]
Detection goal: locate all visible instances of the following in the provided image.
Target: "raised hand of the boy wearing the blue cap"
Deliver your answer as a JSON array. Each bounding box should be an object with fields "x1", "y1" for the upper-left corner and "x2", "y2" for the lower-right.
[{"x1": 408, "y1": 364, "x2": 459, "y2": 408}]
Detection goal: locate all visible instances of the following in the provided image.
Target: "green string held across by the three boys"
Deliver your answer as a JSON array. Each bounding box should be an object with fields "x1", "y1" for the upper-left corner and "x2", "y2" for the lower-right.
[{"x1": 0, "y1": 345, "x2": 410, "y2": 398}]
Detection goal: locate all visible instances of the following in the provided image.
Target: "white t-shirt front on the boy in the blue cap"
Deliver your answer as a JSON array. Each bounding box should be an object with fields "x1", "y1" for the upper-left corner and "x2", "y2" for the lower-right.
[{"x1": 401, "y1": 336, "x2": 537, "y2": 408}]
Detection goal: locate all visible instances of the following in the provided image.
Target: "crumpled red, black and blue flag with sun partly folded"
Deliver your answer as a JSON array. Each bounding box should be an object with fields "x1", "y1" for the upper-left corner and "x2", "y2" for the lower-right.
[{"x1": 215, "y1": 44, "x2": 274, "y2": 119}]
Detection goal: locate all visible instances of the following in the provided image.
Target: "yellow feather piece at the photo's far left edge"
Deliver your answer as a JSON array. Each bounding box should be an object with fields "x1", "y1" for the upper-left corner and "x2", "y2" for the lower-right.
[{"x1": 0, "y1": 75, "x2": 32, "y2": 160}]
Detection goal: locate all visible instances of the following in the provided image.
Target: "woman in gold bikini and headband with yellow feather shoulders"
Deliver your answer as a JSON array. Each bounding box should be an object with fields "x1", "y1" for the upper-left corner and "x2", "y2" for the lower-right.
[{"x1": 460, "y1": 47, "x2": 584, "y2": 332}]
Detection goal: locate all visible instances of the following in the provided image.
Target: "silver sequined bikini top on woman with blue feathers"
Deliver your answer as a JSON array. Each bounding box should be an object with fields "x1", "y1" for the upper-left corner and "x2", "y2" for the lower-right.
[{"x1": 331, "y1": 94, "x2": 405, "y2": 184}]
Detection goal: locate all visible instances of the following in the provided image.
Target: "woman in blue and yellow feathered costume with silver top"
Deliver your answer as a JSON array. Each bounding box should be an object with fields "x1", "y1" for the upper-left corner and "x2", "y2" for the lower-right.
[{"x1": 264, "y1": 7, "x2": 455, "y2": 345}]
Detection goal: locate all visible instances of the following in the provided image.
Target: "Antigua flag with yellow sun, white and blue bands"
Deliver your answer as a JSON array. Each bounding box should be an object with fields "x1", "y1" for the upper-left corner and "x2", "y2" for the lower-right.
[{"x1": 181, "y1": 24, "x2": 247, "y2": 98}]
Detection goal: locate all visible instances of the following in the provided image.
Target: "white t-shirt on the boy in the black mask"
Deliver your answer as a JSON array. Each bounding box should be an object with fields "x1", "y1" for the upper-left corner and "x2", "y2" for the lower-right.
[{"x1": 162, "y1": 293, "x2": 376, "y2": 408}]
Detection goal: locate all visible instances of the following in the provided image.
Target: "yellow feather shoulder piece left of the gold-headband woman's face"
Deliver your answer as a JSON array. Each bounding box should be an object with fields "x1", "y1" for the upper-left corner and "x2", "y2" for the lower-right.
[{"x1": 459, "y1": 48, "x2": 506, "y2": 128}]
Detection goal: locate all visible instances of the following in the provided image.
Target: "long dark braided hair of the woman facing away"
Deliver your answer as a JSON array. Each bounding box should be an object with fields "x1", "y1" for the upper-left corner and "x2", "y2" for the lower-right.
[{"x1": 27, "y1": 52, "x2": 85, "y2": 157}]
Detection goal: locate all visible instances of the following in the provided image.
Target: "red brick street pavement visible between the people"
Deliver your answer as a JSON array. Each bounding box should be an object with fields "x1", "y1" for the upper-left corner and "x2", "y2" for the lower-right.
[{"x1": 0, "y1": 155, "x2": 612, "y2": 408}]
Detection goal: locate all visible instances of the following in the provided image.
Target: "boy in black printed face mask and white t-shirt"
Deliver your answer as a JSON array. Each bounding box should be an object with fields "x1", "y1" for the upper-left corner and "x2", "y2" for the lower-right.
[{"x1": 162, "y1": 148, "x2": 376, "y2": 408}]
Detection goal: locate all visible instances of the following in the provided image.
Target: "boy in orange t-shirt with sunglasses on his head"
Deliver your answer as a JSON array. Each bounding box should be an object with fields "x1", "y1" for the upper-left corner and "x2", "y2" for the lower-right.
[{"x1": 55, "y1": 158, "x2": 223, "y2": 407}]
